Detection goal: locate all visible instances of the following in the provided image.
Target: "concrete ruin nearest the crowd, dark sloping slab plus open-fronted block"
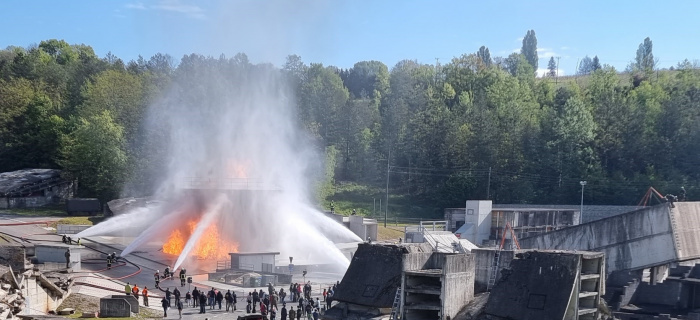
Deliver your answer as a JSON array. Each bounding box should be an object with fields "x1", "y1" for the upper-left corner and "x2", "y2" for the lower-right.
[{"x1": 323, "y1": 243, "x2": 474, "y2": 319}]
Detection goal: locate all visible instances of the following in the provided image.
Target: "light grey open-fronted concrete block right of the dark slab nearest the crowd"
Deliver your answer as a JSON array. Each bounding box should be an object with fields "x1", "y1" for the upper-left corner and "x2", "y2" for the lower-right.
[{"x1": 397, "y1": 252, "x2": 474, "y2": 320}]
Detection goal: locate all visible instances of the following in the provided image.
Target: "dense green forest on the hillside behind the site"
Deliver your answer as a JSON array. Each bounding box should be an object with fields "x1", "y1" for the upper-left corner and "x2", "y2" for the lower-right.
[{"x1": 0, "y1": 31, "x2": 700, "y2": 214}]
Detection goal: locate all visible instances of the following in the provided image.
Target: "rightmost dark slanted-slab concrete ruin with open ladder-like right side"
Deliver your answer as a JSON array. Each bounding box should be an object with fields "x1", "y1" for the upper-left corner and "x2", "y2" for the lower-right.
[{"x1": 484, "y1": 251, "x2": 605, "y2": 320}]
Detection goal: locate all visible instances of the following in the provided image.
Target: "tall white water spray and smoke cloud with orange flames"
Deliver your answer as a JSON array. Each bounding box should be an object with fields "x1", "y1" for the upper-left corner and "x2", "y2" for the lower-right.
[{"x1": 77, "y1": 56, "x2": 361, "y2": 270}]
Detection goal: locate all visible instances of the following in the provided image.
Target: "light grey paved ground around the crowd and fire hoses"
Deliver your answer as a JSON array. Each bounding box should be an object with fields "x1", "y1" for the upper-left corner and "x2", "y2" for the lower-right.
[{"x1": 0, "y1": 214, "x2": 342, "y2": 319}]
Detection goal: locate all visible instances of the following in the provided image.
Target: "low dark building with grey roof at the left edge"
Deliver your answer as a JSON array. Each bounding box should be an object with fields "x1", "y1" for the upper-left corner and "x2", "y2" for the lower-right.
[{"x1": 0, "y1": 169, "x2": 73, "y2": 209}]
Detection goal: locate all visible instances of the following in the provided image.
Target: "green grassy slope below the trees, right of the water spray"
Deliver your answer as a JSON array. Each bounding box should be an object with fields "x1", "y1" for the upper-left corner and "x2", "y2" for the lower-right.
[{"x1": 323, "y1": 183, "x2": 442, "y2": 222}]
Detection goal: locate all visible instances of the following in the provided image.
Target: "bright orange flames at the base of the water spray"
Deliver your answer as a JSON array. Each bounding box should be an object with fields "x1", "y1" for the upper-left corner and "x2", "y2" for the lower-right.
[{"x1": 163, "y1": 220, "x2": 238, "y2": 259}]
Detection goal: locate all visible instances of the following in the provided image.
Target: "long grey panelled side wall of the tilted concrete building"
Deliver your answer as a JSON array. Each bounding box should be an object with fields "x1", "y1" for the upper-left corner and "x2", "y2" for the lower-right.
[{"x1": 520, "y1": 204, "x2": 677, "y2": 272}]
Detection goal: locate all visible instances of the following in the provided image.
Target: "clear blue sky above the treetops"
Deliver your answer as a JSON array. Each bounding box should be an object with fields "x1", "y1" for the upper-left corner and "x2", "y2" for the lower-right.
[{"x1": 0, "y1": 0, "x2": 700, "y2": 74}]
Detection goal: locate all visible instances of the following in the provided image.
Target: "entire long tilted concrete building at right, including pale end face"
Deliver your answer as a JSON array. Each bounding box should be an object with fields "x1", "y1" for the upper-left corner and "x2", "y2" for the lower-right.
[{"x1": 519, "y1": 202, "x2": 700, "y2": 276}]
